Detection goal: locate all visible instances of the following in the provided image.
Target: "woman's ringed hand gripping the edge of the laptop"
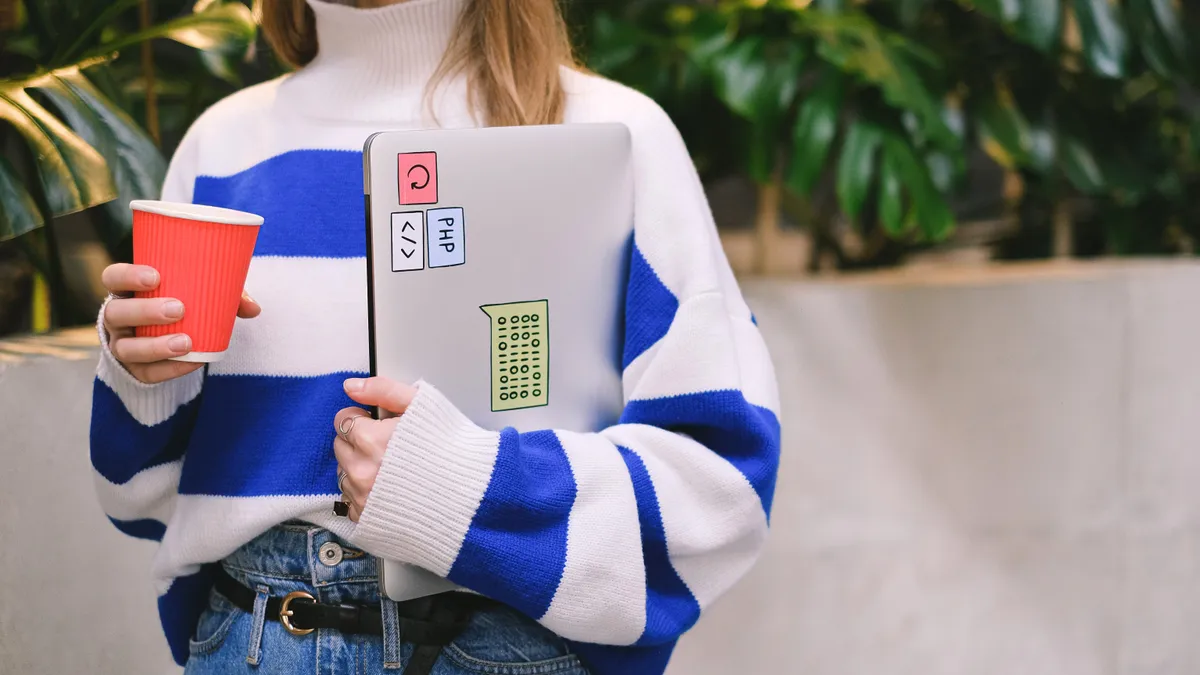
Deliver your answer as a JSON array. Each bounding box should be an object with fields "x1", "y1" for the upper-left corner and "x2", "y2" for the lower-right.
[{"x1": 334, "y1": 377, "x2": 416, "y2": 522}]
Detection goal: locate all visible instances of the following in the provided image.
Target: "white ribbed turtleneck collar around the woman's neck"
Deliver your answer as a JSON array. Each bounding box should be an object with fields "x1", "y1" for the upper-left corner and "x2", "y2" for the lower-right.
[{"x1": 278, "y1": 0, "x2": 466, "y2": 120}]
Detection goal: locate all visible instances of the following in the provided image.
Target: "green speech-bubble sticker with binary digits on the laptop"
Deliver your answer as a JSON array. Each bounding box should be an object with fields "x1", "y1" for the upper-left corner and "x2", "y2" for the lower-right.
[{"x1": 479, "y1": 300, "x2": 550, "y2": 412}]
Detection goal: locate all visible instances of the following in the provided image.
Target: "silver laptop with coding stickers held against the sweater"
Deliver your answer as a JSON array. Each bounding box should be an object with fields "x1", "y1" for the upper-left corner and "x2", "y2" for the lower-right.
[{"x1": 364, "y1": 124, "x2": 634, "y2": 601}]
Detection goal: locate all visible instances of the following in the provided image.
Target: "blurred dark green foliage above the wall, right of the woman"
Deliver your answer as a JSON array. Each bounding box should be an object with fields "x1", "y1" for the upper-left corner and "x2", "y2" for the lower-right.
[{"x1": 574, "y1": 0, "x2": 1200, "y2": 256}]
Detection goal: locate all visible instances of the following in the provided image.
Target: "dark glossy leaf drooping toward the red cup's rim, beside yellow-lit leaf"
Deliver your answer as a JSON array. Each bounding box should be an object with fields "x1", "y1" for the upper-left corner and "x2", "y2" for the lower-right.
[{"x1": 30, "y1": 68, "x2": 167, "y2": 229}]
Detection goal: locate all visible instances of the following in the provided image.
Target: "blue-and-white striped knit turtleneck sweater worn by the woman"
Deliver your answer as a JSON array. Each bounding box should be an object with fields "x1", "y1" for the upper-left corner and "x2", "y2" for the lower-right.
[{"x1": 91, "y1": 0, "x2": 780, "y2": 675}]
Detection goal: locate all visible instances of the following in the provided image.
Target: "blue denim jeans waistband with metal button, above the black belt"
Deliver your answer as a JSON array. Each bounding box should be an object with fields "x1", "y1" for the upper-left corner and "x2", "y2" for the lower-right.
[{"x1": 222, "y1": 522, "x2": 379, "y2": 595}]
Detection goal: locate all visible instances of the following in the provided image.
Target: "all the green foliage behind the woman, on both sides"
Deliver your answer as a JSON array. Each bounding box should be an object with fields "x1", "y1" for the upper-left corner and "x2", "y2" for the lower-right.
[{"x1": 0, "y1": 0, "x2": 1200, "y2": 333}]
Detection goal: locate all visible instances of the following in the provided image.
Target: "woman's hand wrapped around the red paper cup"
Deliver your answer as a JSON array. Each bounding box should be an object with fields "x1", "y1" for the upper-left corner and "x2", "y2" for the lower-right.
[{"x1": 101, "y1": 263, "x2": 263, "y2": 384}]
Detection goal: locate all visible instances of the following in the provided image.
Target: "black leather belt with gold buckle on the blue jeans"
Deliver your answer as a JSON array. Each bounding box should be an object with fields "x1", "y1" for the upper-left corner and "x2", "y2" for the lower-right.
[{"x1": 214, "y1": 567, "x2": 498, "y2": 675}]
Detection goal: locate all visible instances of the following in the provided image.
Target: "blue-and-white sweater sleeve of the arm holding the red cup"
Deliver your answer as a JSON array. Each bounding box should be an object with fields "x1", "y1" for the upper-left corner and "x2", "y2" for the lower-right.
[{"x1": 91, "y1": 131, "x2": 204, "y2": 540}]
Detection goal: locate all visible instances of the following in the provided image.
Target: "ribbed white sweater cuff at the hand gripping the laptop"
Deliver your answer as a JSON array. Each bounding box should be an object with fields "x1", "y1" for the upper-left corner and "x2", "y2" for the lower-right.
[{"x1": 354, "y1": 382, "x2": 500, "y2": 577}]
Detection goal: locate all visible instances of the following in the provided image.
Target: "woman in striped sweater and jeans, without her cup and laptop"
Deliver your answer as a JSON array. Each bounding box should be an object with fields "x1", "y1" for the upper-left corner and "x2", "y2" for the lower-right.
[{"x1": 92, "y1": 0, "x2": 779, "y2": 675}]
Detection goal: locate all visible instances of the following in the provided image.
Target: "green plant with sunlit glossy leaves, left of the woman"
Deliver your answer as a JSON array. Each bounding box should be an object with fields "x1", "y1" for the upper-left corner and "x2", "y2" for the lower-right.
[{"x1": 0, "y1": 0, "x2": 256, "y2": 329}]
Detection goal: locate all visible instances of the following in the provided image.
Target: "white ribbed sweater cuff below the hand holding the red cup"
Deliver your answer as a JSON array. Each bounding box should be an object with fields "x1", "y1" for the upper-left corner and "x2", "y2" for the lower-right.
[{"x1": 96, "y1": 295, "x2": 204, "y2": 426}]
